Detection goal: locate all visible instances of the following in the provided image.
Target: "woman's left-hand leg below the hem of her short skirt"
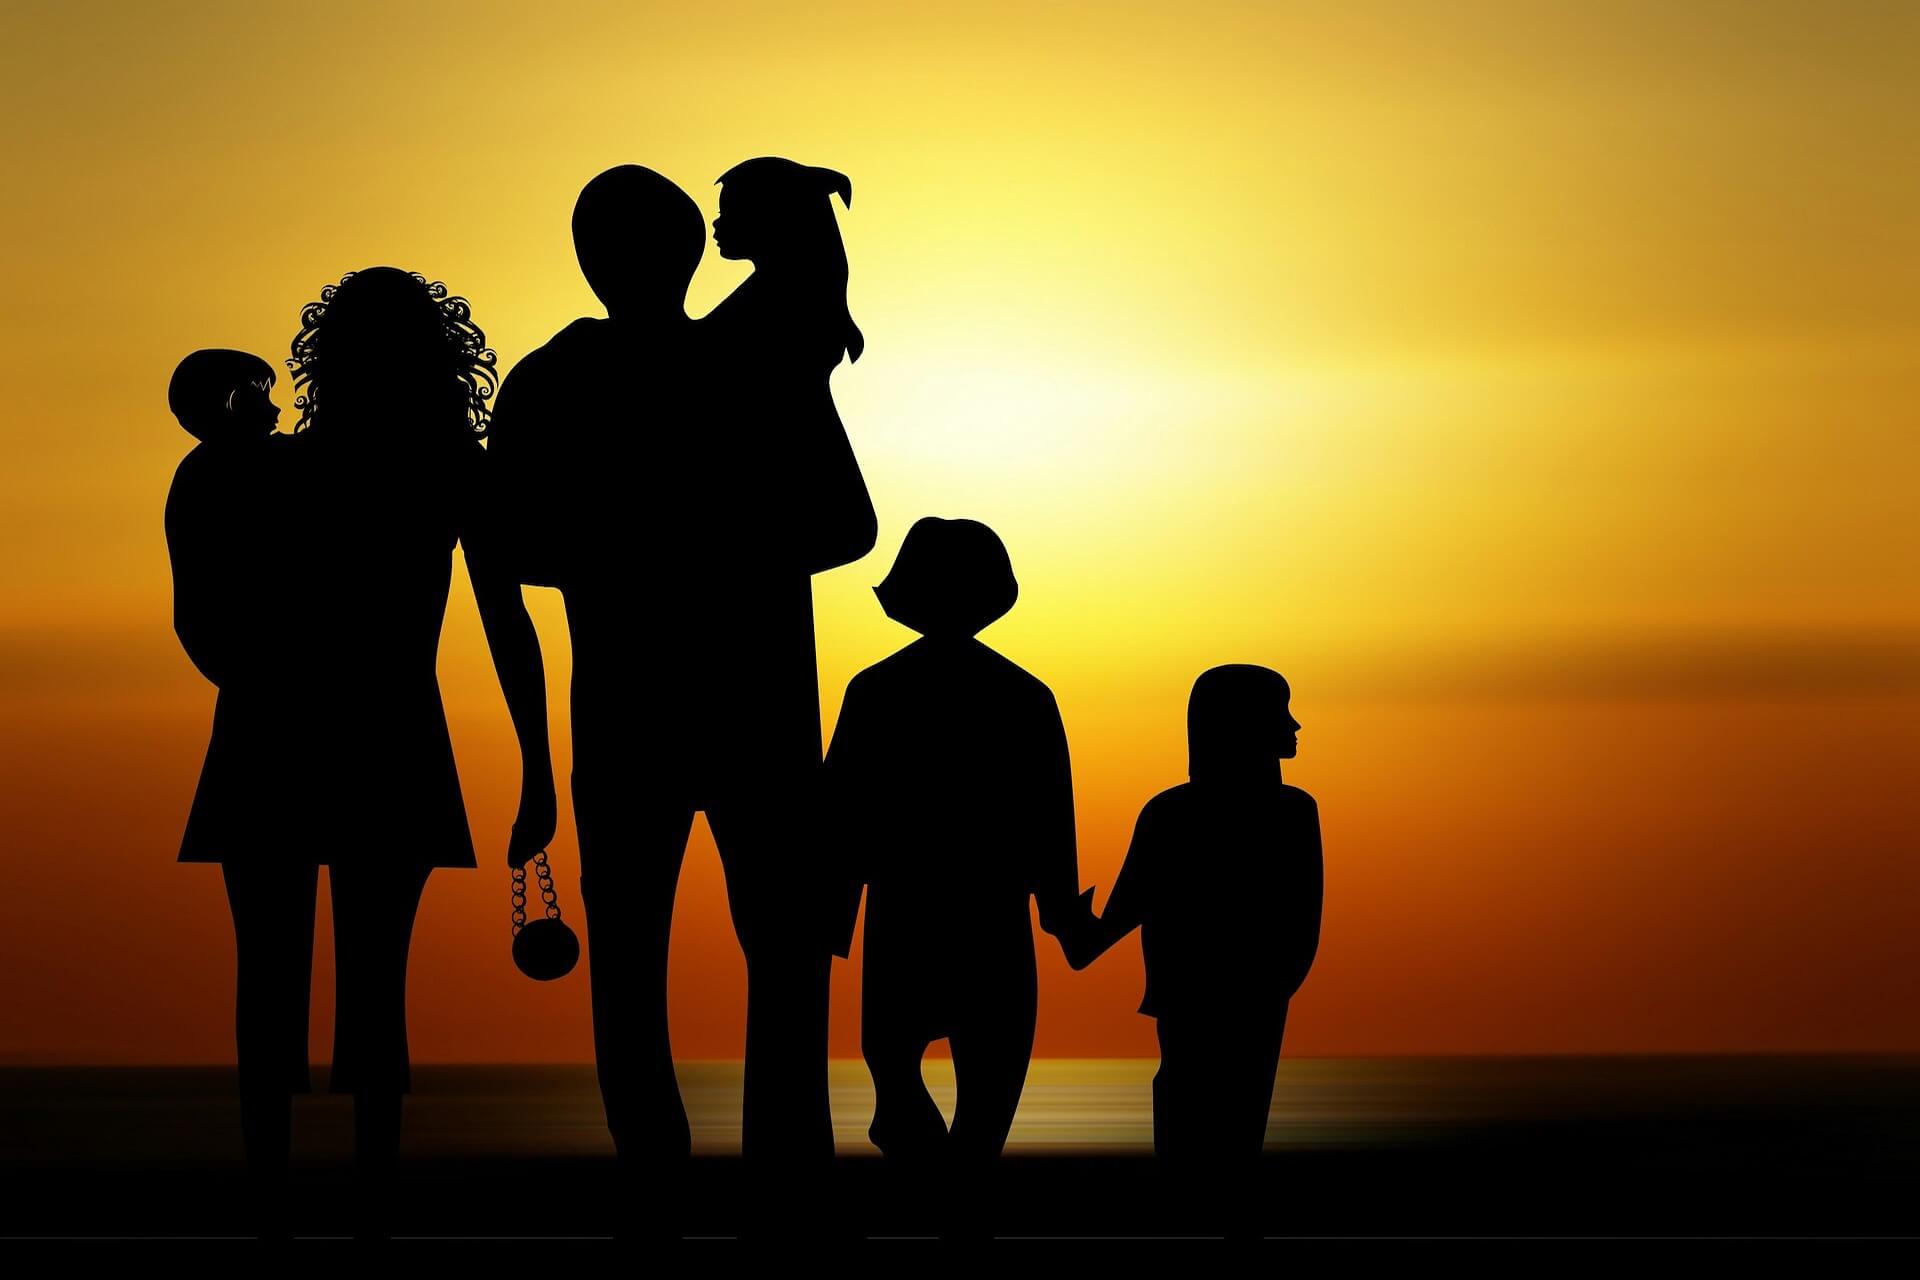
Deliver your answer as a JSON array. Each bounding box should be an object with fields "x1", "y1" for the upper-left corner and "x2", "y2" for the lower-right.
[{"x1": 221, "y1": 862, "x2": 319, "y2": 1180}]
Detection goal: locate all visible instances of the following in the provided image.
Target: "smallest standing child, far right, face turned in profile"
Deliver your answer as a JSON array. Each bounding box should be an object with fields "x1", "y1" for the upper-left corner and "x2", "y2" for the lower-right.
[{"x1": 1069, "y1": 666, "x2": 1323, "y2": 1167}]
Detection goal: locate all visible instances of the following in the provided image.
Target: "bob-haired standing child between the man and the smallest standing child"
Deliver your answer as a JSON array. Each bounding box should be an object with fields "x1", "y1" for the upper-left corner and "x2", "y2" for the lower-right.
[{"x1": 826, "y1": 516, "x2": 1092, "y2": 1167}]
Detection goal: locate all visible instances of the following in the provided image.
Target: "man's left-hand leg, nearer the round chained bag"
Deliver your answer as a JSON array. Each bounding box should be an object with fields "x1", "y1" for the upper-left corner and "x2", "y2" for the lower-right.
[{"x1": 574, "y1": 771, "x2": 693, "y2": 1165}]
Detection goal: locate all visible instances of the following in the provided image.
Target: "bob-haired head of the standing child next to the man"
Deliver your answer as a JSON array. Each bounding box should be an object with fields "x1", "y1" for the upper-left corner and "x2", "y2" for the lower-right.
[{"x1": 874, "y1": 516, "x2": 1020, "y2": 639}]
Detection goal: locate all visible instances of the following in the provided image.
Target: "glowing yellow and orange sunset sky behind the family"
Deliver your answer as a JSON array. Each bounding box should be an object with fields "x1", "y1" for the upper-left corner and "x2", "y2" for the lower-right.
[{"x1": 0, "y1": 0, "x2": 1920, "y2": 1063}]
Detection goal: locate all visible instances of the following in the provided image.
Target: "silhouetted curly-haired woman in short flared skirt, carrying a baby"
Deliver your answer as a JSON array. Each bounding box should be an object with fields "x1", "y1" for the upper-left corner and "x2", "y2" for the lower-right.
[{"x1": 182, "y1": 267, "x2": 553, "y2": 1220}]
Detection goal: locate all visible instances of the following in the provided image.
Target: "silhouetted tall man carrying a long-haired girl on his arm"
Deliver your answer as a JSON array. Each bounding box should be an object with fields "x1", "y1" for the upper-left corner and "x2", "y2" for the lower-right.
[{"x1": 490, "y1": 165, "x2": 864, "y2": 1189}]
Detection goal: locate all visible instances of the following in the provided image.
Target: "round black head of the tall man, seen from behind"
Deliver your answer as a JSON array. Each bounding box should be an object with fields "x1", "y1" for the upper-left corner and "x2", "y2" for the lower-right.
[{"x1": 574, "y1": 165, "x2": 707, "y2": 319}]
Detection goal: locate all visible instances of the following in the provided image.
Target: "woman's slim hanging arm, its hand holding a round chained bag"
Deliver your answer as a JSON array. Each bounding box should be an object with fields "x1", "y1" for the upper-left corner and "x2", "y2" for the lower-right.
[{"x1": 461, "y1": 454, "x2": 559, "y2": 867}]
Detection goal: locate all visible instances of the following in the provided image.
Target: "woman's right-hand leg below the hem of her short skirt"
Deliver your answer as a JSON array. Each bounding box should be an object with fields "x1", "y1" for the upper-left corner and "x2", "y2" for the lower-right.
[{"x1": 328, "y1": 865, "x2": 430, "y2": 1176}]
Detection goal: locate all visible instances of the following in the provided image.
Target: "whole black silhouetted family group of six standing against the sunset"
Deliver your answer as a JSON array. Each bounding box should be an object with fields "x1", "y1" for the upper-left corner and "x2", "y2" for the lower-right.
[{"x1": 167, "y1": 157, "x2": 1321, "y2": 1228}]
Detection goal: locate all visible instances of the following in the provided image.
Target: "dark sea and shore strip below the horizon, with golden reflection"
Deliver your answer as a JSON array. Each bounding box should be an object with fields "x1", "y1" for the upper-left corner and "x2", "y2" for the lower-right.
[{"x1": 0, "y1": 1057, "x2": 1920, "y2": 1238}]
